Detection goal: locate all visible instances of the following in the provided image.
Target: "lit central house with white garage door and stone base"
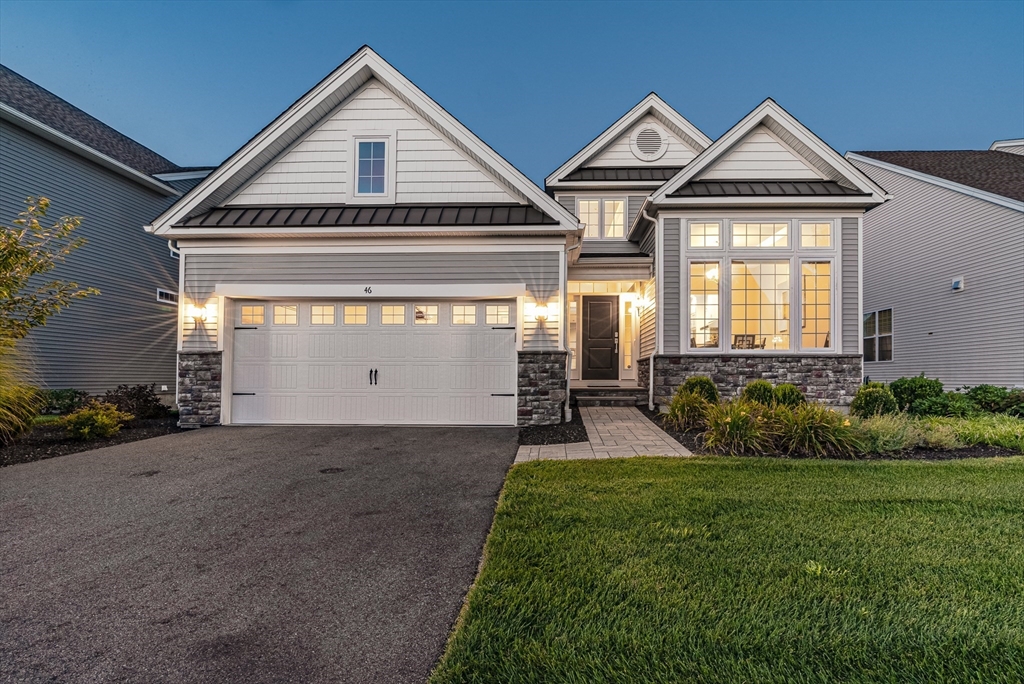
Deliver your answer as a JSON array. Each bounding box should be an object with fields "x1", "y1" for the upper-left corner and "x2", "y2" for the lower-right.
[{"x1": 147, "y1": 47, "x2": 884, "y2": 426}]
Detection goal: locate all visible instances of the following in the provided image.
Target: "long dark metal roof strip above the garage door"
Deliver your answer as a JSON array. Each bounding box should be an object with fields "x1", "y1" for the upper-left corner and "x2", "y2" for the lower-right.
[{"x1": 176, "y1": 205, "x2": 558, "y2": 228}]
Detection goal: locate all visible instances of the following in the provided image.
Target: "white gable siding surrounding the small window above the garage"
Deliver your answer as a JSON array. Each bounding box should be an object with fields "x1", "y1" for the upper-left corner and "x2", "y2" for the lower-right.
[{"x1": 233, "y1": 81, "x2": 517, "y2": 205}]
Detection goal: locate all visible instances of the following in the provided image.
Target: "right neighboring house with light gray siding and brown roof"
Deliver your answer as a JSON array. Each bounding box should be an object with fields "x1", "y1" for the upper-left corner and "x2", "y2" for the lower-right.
[{"x1": 847, "y1": 139, "x2": 1024, "y2": 389}]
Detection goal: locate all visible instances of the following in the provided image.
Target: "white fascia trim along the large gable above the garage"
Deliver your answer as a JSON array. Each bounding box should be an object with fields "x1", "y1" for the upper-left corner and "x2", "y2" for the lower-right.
[{"x1": 146, "y1": 46, "x2": 579, "y2": 234}]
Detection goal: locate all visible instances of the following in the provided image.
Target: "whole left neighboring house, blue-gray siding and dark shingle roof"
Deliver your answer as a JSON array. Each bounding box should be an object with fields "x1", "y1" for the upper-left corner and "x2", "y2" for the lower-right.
[{"x1": 0, "y1": 66, "x2": 207, "y2": 393}]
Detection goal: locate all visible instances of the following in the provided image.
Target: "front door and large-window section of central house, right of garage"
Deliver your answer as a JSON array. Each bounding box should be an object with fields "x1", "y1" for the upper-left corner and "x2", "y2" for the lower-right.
[{"x1": 547, "y1": 94, "x2": 885, "y2": 407}]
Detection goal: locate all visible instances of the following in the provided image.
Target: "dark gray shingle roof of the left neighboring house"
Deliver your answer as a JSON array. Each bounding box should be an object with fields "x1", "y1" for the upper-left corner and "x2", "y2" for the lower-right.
[{"x1": 0, "y1": 65, "x2": 180, "y2": 175}]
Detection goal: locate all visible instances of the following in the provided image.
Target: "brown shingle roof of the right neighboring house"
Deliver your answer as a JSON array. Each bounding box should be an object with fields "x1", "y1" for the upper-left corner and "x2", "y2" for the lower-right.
[{"x1": 854, "y1": 149, "x2": 1024, "y2": 202}]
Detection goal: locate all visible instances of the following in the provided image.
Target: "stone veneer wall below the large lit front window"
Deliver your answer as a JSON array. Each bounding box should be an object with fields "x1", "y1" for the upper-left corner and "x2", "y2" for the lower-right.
[{"x1": 654, "y1": 354, "x2": 862, "y2": 407}]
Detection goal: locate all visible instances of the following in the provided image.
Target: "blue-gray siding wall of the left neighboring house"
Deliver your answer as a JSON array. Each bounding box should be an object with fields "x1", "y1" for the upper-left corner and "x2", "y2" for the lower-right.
[{"x1": 0, "y1": 122, "x2": 178, "y2": 393}]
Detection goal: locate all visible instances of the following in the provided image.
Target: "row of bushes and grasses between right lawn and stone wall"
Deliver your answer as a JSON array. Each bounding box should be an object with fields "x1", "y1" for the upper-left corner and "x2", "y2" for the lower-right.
[{"x1": 663, "y1": 378, "x2": 1024, "y2": 459}]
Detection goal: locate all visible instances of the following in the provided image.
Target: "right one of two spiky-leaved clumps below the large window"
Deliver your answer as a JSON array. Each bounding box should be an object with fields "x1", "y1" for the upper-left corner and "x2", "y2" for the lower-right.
[{"x1": 775, "y1": 403, "x2": 860, "y2": 459}]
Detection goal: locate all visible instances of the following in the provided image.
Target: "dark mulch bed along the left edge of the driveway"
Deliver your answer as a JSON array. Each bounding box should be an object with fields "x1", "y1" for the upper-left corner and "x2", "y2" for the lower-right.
[{"x1": 0, "y1": 416, "x2": 183, "y2": 468}]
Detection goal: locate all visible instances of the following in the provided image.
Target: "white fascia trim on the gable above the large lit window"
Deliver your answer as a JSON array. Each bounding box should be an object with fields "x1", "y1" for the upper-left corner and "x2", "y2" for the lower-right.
[{"x1": 651, "y1": 97, "x2": 888, "y2": 205}]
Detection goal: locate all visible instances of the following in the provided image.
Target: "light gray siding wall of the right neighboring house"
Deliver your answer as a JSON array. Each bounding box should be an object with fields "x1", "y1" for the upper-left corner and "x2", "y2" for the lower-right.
[{"x1": 854, "y1": 156, "x2": 1024, "y2": 388}]
